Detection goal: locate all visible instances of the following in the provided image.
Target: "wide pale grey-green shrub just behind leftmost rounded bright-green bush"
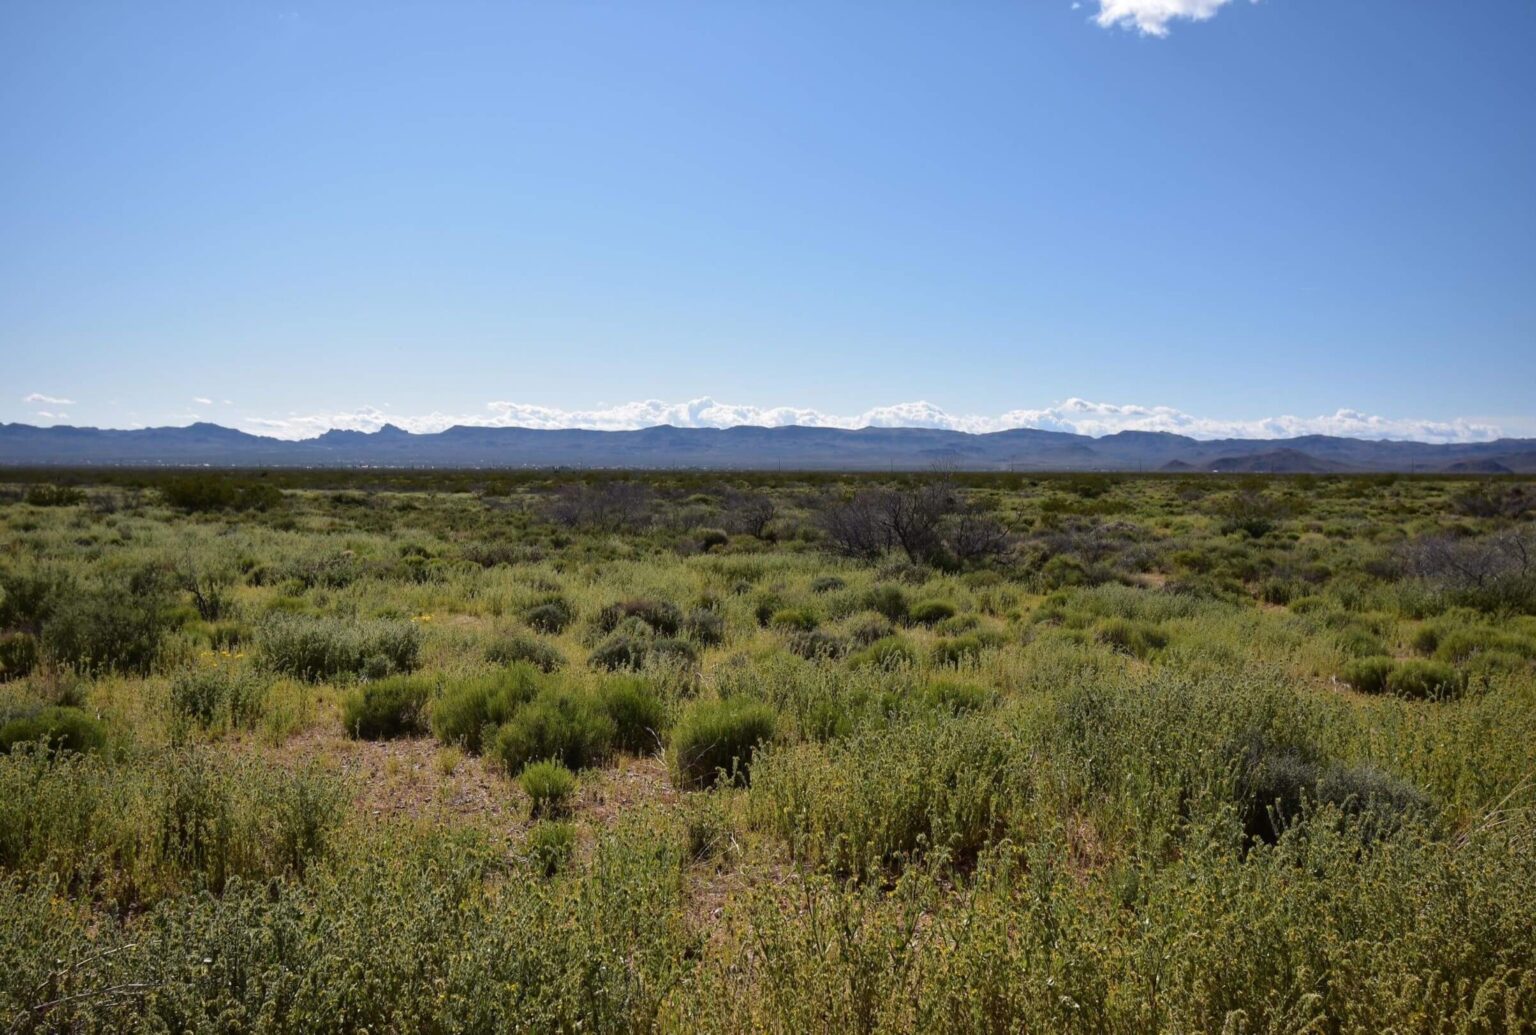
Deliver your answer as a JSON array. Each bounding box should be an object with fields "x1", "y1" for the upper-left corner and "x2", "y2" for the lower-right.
[{"x1": 257, "y1": 613, "x2": 421, "y2": 682}]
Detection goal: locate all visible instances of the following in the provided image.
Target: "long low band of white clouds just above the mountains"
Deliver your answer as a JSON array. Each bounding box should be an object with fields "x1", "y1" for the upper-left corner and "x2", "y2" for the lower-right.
[{"x1": 241, "y1": 396, "x2": 1499, "y2": 442}]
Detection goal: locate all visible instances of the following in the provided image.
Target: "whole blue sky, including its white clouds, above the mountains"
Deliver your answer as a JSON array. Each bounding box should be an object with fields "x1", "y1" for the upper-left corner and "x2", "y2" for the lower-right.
[{"x1": 0, "y1": 0, "x2": 1536, "y2": 438}]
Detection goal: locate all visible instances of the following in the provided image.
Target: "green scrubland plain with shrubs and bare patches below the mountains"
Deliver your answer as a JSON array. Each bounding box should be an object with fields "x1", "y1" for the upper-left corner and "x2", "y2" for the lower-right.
[{"x1": 0, "y1": 471, "x2": 1536, "y2": 1033}]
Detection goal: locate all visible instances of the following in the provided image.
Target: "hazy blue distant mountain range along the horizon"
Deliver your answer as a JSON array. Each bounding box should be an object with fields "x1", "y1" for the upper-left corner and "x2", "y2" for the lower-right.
[{"x1": 0, "y1": 424, "x2": 1536, "y2": 475}]
